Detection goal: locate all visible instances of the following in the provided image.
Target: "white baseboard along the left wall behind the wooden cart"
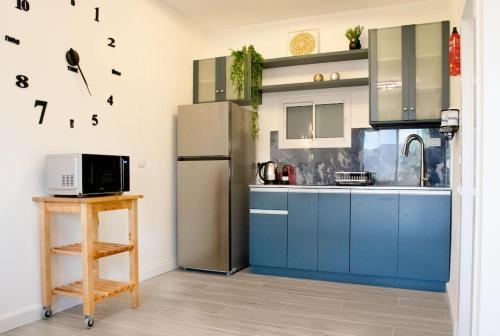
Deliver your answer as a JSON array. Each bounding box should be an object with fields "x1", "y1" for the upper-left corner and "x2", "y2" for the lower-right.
[{"x1": 0, "y1": 260, "x2": 178, "y2": 334}]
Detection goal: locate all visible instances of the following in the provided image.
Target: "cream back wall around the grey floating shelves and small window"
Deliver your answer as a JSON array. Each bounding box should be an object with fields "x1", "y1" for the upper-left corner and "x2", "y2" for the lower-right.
[{"x1": 201, "y1": 0, "x2": 449, "y2": 161}]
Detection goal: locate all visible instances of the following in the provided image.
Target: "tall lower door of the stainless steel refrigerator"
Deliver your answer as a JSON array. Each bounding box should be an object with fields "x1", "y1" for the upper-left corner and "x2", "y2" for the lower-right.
[{"x1": 177, "y1": 160, "x2": 231, "y2": 272}]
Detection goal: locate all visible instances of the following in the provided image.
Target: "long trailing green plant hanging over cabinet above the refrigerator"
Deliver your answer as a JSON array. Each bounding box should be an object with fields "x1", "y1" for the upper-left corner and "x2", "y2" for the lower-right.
[{"x1": 231, "y1": 45, "x2": 264, "y2": 139}]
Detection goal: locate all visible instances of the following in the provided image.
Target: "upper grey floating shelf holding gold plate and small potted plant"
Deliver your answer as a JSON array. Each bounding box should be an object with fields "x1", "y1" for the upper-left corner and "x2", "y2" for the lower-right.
[{"x1": 262, "y1": 49, "x2": 368, "y2": 69}]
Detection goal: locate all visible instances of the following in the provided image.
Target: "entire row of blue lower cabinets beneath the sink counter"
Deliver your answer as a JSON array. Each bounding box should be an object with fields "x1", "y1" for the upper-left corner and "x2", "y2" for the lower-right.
[{"x1": 250, "y1": 188, "x2": 451, "y2": 291}]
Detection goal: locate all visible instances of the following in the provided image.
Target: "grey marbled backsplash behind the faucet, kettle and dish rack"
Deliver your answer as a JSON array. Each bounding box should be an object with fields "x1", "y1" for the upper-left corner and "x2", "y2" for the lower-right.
[{"x1": 270, "y1": 128, "x2": 450, "y2": 187}]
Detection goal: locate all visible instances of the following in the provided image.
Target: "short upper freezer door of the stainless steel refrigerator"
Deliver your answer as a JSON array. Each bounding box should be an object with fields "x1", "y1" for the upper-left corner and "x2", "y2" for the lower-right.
[{"x1": 177, "y1": 102, "x2": 230, "y2": 157}]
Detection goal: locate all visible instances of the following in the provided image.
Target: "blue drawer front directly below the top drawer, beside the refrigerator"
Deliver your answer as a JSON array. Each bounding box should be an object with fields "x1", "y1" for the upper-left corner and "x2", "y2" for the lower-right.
[{"x1": 250, "y1": 210, "x2": 287, "y2": 267}]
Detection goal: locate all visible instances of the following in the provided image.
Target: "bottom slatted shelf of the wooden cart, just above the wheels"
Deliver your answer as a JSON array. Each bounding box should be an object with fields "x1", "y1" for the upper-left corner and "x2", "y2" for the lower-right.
[{"x1": 52, "y1": 279, "x2": 134, "y2": 302}]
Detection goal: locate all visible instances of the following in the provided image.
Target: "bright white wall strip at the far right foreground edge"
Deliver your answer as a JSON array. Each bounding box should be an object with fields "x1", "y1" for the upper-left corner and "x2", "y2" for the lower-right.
[{"x1": 472, "y1": 0, "x2": 500, "y2": 336}]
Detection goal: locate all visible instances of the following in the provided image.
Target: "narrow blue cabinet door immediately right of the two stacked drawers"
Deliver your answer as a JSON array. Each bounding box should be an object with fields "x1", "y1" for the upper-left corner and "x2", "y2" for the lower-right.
[{"x1": 288, "y1": 190, "x2": 318, "y2": 271}]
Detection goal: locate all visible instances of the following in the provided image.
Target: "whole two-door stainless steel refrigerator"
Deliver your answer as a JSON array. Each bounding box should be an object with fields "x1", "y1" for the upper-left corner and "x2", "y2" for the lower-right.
[{"x1": 177, "y1": 102, "x2": 255, "y2": 274}]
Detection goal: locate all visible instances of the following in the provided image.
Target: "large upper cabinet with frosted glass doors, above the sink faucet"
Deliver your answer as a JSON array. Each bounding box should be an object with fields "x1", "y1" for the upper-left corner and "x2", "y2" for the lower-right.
[{"x1": 369, "y1": 21, "x2": 450, "y2": 127}]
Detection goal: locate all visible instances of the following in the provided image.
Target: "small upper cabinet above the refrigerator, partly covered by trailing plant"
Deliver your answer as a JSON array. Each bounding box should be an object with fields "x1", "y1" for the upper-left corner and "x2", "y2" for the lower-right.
[{"x1": 193, "y1": 56, "x2": 251, "y2": 105}]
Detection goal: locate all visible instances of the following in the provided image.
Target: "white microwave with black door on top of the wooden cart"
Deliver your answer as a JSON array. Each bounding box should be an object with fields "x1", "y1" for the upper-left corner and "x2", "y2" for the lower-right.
[{"x1": 45, "y1": 153, "x2": 130, "y2": 196}]
